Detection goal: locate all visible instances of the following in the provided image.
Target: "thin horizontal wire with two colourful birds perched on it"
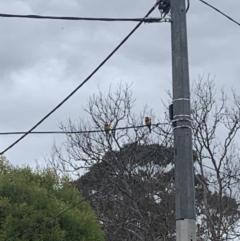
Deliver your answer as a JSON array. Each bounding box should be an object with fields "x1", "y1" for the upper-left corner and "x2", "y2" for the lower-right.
[{"x1": 0, "y1": 123, "x2": 168, "y2": 135}]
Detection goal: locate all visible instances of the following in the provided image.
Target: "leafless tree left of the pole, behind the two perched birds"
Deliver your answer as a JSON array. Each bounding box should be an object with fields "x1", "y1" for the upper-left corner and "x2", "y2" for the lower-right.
[{"x1": 47, "y1": 84, "x2": 174, "y2": 241}]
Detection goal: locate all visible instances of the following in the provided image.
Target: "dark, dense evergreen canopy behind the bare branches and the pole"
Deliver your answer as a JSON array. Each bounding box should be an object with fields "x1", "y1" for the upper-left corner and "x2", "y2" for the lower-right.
[{"x1": 75, "y1": 144, "x2": 240, "y2": 241}]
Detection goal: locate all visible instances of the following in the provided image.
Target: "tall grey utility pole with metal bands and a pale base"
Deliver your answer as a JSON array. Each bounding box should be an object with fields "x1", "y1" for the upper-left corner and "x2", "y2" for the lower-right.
[{"x1": 171, "y1": 0, "x2": 196, "y2": 241}]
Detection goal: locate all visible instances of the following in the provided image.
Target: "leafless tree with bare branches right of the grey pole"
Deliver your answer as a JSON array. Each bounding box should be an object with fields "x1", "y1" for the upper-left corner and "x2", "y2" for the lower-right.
[{"x1": 192, "y1": 76, "x2": 240, "y2": 241}]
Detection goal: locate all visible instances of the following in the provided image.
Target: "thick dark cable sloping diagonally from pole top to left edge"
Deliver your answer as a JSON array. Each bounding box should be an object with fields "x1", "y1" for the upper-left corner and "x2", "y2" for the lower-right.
[{"x1": 0, "y1": 0, "x2": 160, "y2": 155}]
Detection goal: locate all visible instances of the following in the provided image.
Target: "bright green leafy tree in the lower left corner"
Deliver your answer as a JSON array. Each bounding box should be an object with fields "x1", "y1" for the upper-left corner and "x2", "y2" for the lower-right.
[{"x1": 0, "y1": 158, "x2": 104, "y2": 241}]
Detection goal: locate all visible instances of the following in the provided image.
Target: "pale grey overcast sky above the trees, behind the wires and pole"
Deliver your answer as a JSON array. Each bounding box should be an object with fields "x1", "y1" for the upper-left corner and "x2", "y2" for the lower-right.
[{"x1": 0, "y1": 0, "x2": 240, "y2": 166}]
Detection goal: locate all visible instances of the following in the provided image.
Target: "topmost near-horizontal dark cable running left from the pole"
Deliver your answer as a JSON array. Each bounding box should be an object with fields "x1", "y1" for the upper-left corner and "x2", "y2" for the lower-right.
[{"x1": 0, "y1": 13, "x2": 162, "y2": 23}]
